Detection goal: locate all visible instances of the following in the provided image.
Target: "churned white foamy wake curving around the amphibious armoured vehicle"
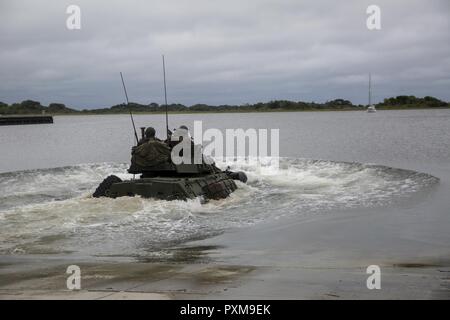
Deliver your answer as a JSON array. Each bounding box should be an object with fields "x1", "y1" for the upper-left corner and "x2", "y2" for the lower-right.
[{"x1": 0, "y1": 159, "x2": 438, "y2": 257}]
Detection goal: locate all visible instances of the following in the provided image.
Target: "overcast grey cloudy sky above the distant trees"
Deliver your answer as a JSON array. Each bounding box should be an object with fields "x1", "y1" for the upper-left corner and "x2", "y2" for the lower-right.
[{"x1": 0, "y1": 0, "x2": 450, "y2": 108}]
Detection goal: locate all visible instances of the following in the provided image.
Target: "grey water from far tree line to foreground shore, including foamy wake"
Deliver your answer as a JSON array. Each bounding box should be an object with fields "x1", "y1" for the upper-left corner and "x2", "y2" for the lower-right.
[{"x1": 0, "y1": 110, "x2": 450, "y2": 259}]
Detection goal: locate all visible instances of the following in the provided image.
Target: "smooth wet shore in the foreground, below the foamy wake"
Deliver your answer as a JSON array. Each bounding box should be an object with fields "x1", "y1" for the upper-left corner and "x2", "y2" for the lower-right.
[{"x1": 0, "y1": 202, "x2": 450, "y2": 300}]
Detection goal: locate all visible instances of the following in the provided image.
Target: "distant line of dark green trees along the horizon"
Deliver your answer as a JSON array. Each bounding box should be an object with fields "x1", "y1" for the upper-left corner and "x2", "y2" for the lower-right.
[{"x1": 0, "y1": 96, "x2": 450, "y2": 115}]
